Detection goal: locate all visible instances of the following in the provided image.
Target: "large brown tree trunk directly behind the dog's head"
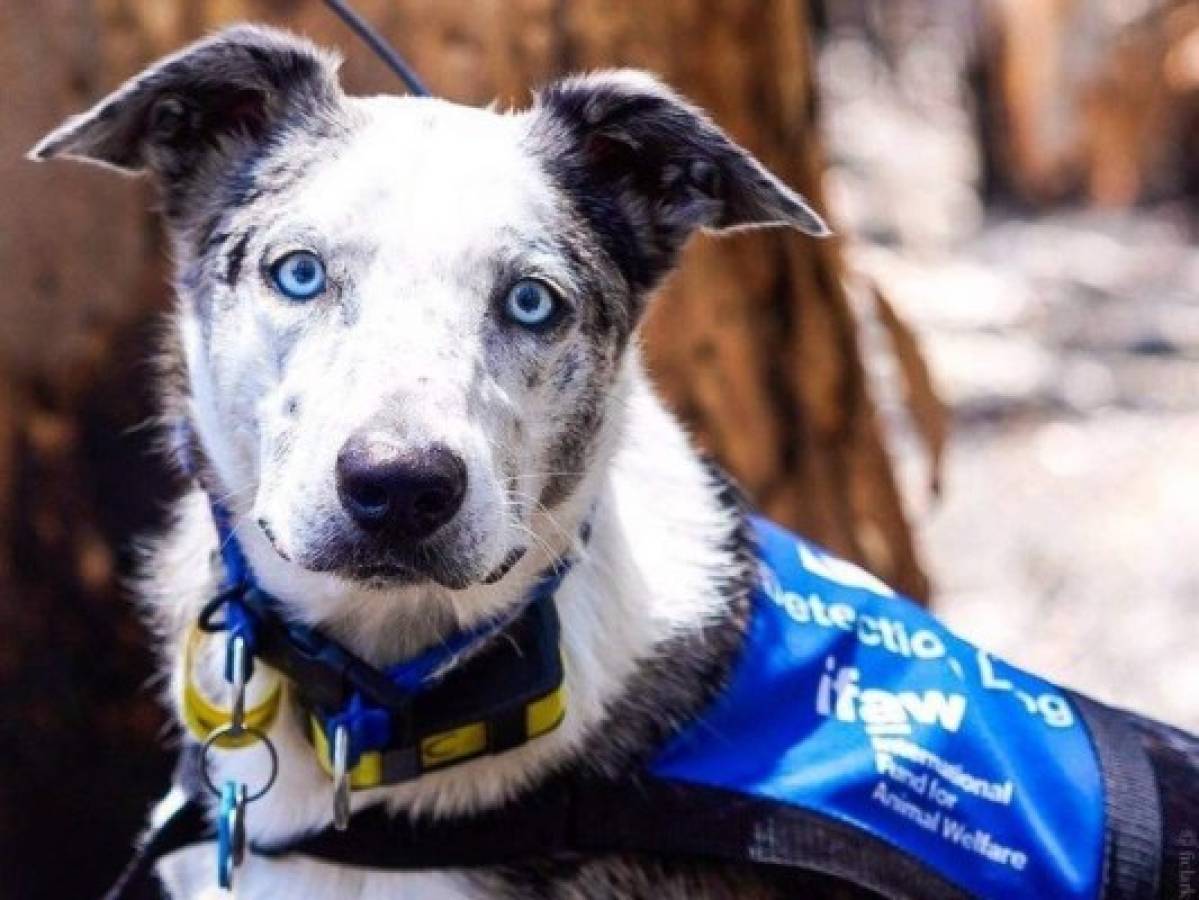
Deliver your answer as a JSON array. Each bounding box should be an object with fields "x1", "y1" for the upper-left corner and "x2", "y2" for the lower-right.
[{"x1": 0, "y1": 0, "x2": 927, "y2": 896}]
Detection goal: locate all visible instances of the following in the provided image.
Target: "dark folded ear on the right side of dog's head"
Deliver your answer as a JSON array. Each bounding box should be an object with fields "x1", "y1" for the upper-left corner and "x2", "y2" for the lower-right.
[{"x1": 534, "y1": 70, "x2": 831, "y2": 286}]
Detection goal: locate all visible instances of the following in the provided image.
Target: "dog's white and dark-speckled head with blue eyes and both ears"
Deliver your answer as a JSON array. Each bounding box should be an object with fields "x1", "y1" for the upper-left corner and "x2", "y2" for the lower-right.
[{"x1": 34, "y1": 26, "x2": 825, "y2": 599}]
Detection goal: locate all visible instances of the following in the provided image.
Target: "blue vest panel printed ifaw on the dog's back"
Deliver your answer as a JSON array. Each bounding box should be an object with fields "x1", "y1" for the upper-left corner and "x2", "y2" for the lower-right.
[{"x1": 650, "y1": 520, "x2": 1105, "y2": 898}]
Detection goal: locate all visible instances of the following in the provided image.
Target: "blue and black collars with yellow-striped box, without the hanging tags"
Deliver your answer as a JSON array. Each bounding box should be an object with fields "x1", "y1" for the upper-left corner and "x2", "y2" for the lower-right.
[{"x1": 199, "y1": 505, "x2": 575, "y2": 789}]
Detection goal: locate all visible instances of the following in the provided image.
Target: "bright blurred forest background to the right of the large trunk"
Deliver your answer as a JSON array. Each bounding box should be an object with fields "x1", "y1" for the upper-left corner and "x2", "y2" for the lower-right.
[{"x1": 818, "y1": 0, "x2": 1199, "y2": 730}]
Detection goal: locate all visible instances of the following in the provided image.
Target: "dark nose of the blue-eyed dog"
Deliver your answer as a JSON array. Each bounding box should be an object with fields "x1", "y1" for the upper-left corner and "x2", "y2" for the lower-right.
[{"x1": 337, "y1": 431, "x2": 466, "y2": 540}]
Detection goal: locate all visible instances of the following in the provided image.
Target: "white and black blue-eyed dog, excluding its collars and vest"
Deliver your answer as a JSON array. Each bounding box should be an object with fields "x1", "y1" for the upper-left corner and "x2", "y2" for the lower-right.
[{"x1": 34, "y1": 19, "x2": 1194, "y2": 900}]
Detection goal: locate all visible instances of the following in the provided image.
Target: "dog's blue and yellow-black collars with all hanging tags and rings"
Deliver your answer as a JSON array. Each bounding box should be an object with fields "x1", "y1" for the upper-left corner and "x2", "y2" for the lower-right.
[{"x1": 181, "y1": 493, "x2": 589, "y2": 887}]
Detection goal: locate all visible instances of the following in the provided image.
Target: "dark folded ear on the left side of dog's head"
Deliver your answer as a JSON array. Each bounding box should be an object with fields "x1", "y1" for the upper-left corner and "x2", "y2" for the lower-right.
[{"x1": 29, "y1": 25, "x2": 342, "y2": 191}]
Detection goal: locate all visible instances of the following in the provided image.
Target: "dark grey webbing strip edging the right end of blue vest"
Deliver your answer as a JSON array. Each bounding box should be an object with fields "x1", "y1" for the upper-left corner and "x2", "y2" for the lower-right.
[{"x1": 1070, "y1": 693, "x2": 1162, "y2": 900}]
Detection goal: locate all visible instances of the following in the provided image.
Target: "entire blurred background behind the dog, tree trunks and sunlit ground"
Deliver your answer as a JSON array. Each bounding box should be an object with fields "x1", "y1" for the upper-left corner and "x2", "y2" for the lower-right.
[{"x1": 0, "y1": 0, "x2": 1199, "y2": 898}]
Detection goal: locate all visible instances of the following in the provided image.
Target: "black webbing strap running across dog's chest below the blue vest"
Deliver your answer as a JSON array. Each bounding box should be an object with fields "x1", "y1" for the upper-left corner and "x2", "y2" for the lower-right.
[{"x1": 253, "y1": 778, "x2": 969, "y2": 900}]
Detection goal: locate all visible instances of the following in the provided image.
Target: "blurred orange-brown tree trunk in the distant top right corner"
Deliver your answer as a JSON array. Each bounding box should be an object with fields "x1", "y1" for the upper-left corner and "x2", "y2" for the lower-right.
[{"x1": 978, "y1": 0, "x2": 1199, "y2": 207}]
